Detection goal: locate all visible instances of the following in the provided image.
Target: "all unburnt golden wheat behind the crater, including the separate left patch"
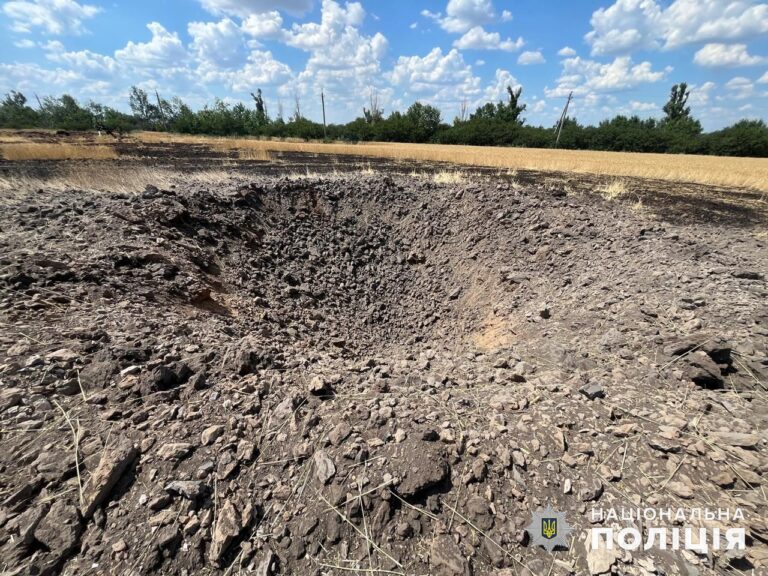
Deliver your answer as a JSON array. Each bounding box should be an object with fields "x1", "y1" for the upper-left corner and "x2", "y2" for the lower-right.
[{"x1": 0, "y1": 132, "x2": 768, "y2": 192}]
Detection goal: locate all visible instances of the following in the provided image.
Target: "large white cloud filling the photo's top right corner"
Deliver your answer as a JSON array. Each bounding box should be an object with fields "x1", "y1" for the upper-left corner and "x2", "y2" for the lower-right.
[{"x1": 585, "y1": 0, "x2": 768, "y2": 55}]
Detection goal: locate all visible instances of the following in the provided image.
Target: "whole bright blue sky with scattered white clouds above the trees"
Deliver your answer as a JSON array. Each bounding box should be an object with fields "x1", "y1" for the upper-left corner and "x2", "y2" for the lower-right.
[{"x1": 0, "y1": 0, "x2": 768, "y2": 130}]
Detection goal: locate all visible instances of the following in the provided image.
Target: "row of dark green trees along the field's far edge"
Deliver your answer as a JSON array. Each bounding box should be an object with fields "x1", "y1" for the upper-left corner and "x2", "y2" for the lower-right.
[{"x1": 0, "y1": 83, "x2": 768, "y2": 157}]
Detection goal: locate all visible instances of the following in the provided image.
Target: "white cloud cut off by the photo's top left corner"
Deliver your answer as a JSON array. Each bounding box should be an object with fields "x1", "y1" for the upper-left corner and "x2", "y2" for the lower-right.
[{"x1": 3, "y1": 0, "x2": 101, "y2": 35}]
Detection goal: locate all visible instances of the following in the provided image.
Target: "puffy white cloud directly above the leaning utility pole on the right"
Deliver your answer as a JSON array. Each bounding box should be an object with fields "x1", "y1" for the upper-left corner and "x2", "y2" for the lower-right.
[{"x1": 544, "y1": 56, "x2": 671, "y2": 97}]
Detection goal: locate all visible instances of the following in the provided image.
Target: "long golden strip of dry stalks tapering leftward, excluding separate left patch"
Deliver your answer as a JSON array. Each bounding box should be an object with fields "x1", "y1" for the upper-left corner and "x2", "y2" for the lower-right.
[{"x1": 136, "y1": 132, "x2": 768, "y2": 191}]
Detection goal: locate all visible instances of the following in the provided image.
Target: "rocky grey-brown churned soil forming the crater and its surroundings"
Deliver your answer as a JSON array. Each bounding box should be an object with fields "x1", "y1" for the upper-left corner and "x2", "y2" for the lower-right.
[{"x1": 0, "y1": 132, "x2": 768, "y2": 575}]
